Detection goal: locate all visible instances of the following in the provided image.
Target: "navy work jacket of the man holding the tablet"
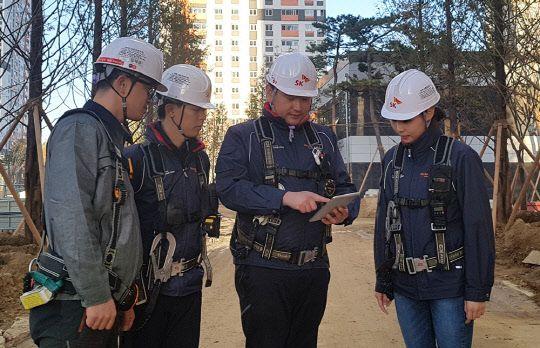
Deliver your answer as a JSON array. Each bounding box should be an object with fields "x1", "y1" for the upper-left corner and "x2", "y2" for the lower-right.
[{"x1": 216, "y1": 104, "x2": 359, "y2": 269}]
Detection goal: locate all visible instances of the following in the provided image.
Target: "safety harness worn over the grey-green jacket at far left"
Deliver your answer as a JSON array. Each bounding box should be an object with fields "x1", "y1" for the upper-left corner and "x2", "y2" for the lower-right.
[{"x1": 25, "y1": 109, "x2": 137, "y2": 310}]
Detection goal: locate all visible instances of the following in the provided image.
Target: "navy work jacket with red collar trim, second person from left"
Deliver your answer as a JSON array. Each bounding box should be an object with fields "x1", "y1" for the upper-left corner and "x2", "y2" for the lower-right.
[{"x1": 125, "y1": 122, "x2": 210, "y2": 296}]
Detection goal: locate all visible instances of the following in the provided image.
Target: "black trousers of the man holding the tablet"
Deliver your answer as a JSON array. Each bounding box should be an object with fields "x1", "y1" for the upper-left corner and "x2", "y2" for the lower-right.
[{"x1": 235, "y1": 265, "x2": 330, "y2": 348}]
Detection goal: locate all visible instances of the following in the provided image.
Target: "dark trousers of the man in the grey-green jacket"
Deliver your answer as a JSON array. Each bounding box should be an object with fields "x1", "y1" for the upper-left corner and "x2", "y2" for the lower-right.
[{"x1": 30, "y1": 300, "x2": 121, "y2": 348}]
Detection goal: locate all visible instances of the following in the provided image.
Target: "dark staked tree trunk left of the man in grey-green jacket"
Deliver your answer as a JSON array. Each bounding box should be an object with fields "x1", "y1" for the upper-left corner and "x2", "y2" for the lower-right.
[{"x1": 24, "y1": 0, "x2": 43, "y2": 240}]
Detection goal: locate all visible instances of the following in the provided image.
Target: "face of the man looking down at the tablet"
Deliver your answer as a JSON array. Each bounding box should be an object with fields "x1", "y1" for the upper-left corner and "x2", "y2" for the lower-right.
[{"x1": 266, "y1": 85, "x2": 311, "y2": 126}]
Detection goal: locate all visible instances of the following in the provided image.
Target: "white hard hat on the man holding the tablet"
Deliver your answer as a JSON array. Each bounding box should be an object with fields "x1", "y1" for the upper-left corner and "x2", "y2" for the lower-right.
[{"x1": 266, "y1": 53, "x2": 318, "y2": 97}]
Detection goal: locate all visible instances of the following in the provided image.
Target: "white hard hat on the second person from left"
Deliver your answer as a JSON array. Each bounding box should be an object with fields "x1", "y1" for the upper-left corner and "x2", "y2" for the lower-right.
[{"x1": 158, "y1": 64, "x2": 216, "y2": 109}]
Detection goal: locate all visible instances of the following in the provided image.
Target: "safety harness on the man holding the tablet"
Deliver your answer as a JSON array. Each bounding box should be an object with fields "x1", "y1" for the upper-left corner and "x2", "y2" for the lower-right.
[{"x1": 231, "y1": 116, "x2": 336, "y2": 266}]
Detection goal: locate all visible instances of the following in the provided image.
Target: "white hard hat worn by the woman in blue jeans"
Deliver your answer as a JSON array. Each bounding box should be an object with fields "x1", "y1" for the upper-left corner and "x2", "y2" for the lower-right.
[{"x1": 381, "y1": 69, "x2": 441, "y2": 121}]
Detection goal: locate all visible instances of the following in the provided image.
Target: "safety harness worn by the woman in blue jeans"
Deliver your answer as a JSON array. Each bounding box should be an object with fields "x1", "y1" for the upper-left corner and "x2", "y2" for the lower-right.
[{"x1": 386, "y1": 135, "x2": 464, "y2": 274}]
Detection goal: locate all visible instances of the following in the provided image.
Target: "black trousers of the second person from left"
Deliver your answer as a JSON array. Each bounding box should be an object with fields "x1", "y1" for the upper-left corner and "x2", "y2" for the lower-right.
[{"x1": 123, "y1": 291, "x2": 202, "y2": 348}]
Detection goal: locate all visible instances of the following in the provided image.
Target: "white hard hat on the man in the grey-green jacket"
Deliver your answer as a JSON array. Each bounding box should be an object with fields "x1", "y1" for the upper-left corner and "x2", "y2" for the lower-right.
[{"x1": 94, "y1": 37, "x2": 167, "y2": 91}]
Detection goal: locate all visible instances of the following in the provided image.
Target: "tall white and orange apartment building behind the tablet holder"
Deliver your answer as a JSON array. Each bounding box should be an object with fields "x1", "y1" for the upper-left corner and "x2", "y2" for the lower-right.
[{"x1": 189, "y1": 0, "x2": 327, "y2": 122}]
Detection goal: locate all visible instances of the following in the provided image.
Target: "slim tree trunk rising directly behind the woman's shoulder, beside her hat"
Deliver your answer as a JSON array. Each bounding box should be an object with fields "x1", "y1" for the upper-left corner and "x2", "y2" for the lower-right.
[{"x1": 444, "y1": 0, "x2": 459, "y2": 136}]
